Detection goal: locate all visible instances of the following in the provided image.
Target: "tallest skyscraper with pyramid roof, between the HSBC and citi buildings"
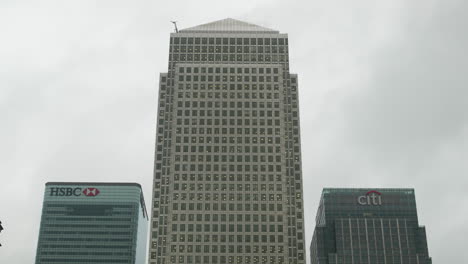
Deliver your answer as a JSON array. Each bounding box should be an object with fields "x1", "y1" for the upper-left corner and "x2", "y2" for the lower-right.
[{"x1": 149, "y1": 19, "x2": 305, "y2": 264}]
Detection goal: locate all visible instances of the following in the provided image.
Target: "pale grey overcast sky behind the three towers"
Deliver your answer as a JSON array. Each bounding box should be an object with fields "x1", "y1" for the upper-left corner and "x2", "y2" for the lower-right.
[{"x1": 0, "y1": 0, "x2": 468, "y2": 264}]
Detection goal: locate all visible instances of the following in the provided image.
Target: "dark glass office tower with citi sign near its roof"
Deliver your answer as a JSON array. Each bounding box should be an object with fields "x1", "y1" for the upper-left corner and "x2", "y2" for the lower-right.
[{"x1": 310, "y1": 189, "x2": 432, "y2": 264}]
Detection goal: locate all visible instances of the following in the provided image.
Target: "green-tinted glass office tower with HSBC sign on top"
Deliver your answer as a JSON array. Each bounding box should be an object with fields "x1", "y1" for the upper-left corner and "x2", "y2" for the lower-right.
[{"x1": 36, "y1": 182, "x2": 148, "y2": 264}]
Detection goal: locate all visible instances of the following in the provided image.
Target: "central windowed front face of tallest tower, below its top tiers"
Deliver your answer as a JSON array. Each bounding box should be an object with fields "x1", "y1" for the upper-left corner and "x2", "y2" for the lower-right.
[{"x1": 163, "y1": 64, "x2": 287, "y2": 263}]
